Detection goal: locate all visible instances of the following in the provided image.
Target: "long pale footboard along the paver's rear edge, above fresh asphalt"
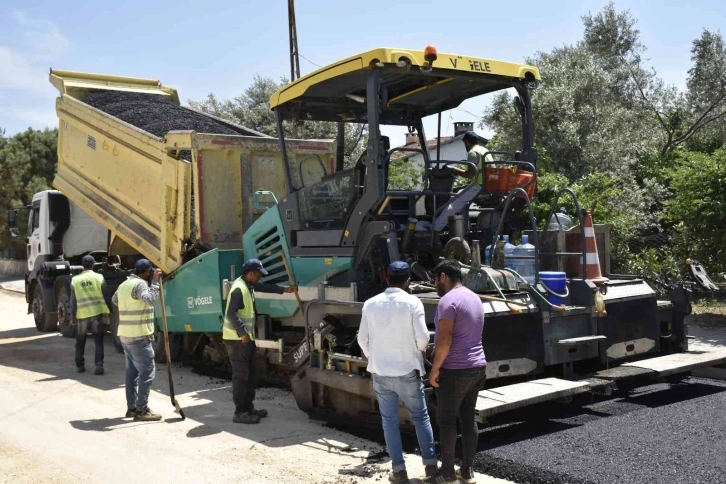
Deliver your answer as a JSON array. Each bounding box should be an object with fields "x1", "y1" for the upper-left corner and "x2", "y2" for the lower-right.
[{"x1": 476, "y1": 350, "x2": 726, "y2": 423}]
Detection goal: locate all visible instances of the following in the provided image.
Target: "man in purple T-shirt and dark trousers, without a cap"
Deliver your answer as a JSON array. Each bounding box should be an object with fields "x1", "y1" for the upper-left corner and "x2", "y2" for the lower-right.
[{"x1": 424, "y1": 259, "x2": 486, "y2": 484}]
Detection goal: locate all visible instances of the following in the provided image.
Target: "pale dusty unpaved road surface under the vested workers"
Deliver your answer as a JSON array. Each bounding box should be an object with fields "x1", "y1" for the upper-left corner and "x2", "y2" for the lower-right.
[{"x1": 0, "y1": 291, "x2": 505, "y2": 484}]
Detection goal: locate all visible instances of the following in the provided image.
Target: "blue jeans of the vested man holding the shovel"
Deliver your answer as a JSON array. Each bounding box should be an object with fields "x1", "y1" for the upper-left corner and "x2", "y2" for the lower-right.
[{"x1": 119, "y1": 336, "x2": 156, "y2": 412}]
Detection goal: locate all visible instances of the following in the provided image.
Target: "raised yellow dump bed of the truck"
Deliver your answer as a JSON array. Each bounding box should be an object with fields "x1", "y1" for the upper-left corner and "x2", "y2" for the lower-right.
[{"x1": 50, "y1": 70, "x2": 335, "y2": 273}]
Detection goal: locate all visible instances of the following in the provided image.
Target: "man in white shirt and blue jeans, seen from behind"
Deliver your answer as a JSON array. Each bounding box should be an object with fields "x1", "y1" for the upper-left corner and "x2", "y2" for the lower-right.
[{"x1": 358, "y1": 261, "x2": 437, "y2": 482}]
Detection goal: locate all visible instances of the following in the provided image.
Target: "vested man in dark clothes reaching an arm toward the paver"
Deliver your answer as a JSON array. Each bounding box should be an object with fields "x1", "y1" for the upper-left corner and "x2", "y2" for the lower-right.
[{"x1": 222, "y1": 259, "x2": 297, "y2": 424}]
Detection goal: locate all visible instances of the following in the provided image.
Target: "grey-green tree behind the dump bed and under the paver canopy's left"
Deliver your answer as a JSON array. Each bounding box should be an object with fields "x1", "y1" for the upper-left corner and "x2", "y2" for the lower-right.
[{"x1": 188, "y1": 75, "x2": 366, "y2": 166}]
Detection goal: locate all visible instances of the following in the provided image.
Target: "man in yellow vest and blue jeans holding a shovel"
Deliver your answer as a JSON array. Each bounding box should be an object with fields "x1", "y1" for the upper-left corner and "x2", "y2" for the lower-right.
[{"x1": 112, "y1": 259, "x2": 161, "y2": 422}]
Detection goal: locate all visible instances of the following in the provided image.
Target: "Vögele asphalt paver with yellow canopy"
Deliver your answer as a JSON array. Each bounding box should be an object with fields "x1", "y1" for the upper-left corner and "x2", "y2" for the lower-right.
[{"x1": 237, "y1": 47, "x2": 726, "y2": 424}]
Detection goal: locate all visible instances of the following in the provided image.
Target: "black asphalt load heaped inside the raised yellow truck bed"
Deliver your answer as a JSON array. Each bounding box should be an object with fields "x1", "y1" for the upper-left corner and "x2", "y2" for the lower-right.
[{"x1": 83, "y1": 91, "x2": 244, "y2": 138}]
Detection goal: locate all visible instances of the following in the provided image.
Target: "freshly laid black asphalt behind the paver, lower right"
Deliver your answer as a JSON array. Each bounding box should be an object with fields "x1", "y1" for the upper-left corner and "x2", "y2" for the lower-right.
[{"x1": 474, "y1": 378, "x2": 726, "y2": 484}]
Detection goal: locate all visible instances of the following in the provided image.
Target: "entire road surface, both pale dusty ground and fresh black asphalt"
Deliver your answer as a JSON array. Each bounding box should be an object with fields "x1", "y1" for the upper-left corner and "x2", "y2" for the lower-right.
[{"x1": 5, "y1": 280, "x2": 726, "y2": 484}]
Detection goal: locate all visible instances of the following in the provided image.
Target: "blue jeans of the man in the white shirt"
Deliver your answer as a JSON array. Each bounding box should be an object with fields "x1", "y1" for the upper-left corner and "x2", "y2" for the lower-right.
[{"x1": 373, "y1": 370, "x2": 436, "y2": 472}]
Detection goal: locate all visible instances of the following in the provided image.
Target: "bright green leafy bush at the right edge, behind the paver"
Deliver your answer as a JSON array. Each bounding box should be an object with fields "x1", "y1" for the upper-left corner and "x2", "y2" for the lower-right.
[{"x1": 664, "y1": 150, "x2": 726, "y2": 272}]
